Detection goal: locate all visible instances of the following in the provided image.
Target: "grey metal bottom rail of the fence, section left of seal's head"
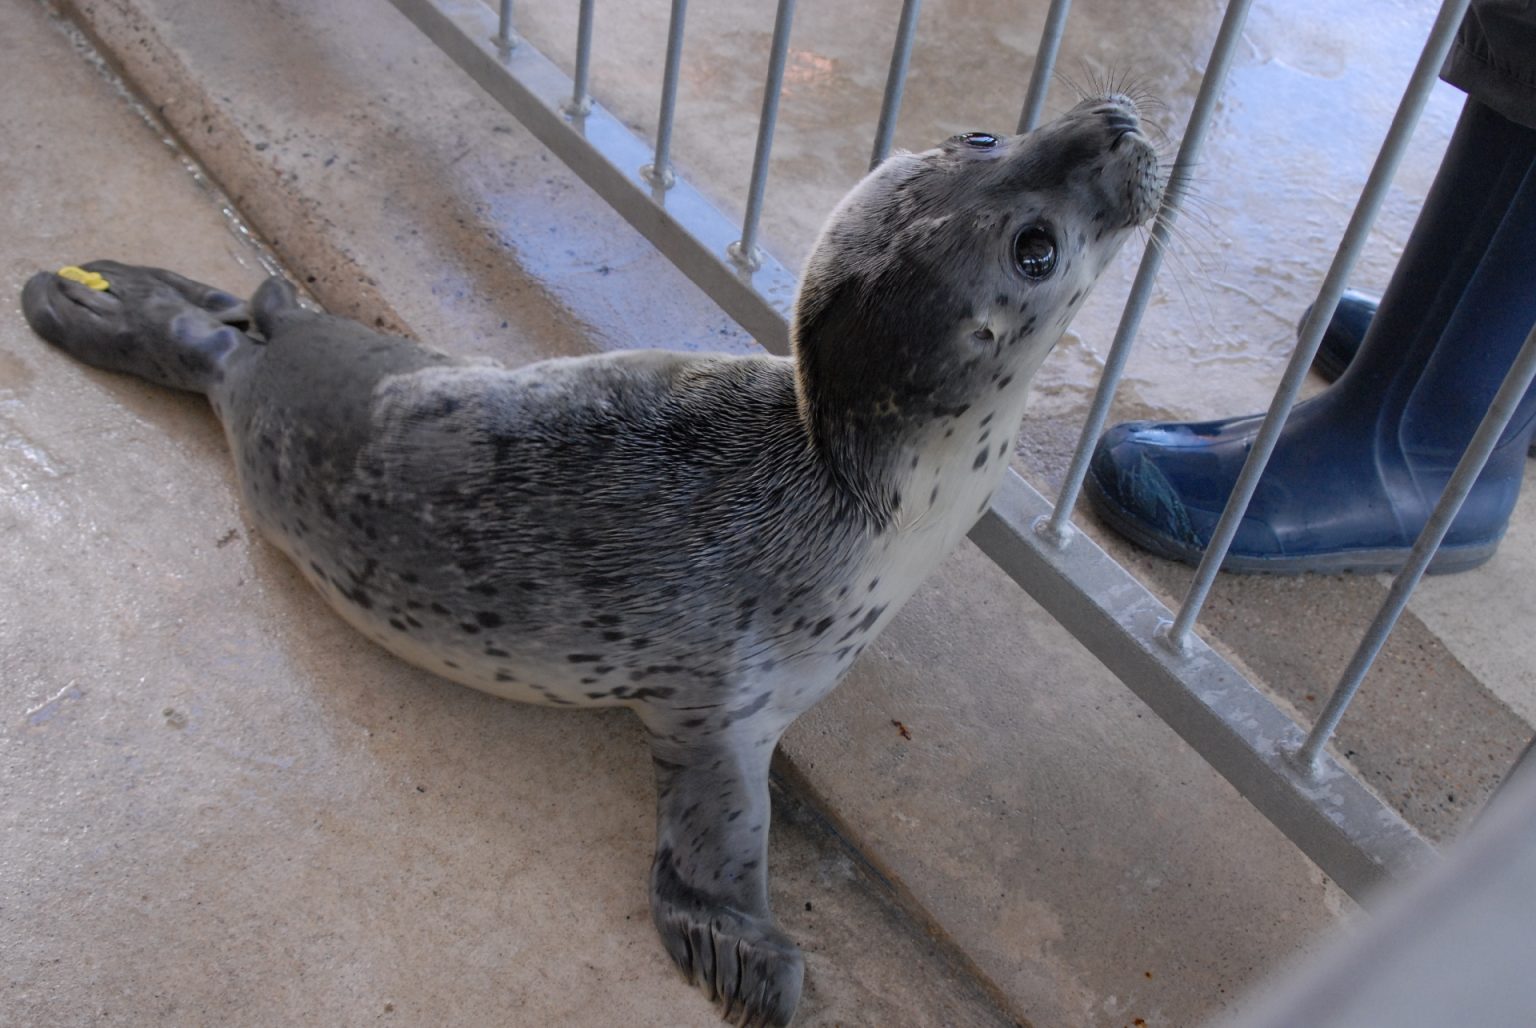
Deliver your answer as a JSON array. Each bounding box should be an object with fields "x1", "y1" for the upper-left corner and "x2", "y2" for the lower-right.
[{"x1": 390, "y1": 0, "x2": 796, "y2": 353}]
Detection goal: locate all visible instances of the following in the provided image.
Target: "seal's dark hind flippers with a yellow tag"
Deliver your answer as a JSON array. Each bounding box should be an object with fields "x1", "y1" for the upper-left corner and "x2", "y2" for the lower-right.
[{"x1": 22, "y1": 261, "x2": 252, "y2": 393}]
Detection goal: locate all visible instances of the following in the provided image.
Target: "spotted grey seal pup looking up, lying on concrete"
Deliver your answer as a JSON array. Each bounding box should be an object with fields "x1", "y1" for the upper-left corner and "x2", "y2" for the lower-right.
[{"x1": 23, "y1": 95, "x2": 1161, "y2": 1025}]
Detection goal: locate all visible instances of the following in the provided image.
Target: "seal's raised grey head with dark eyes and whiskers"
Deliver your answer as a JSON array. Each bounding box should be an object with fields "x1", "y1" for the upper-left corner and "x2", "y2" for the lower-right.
[{"x1": 793, "y1": 95, "x2": 1163, "y2": 510}]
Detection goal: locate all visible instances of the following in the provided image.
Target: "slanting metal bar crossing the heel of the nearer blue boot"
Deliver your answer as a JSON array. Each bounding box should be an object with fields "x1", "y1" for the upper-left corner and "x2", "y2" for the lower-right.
[{"x1": 1296, "y1": 327, "x2": 1536, "y2": 773}]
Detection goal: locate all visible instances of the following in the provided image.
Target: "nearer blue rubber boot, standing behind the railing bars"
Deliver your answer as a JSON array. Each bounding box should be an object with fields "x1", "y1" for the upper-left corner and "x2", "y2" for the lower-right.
[{"x1": 1086, "y1": 100, "x2": 1536, "y2": 573}]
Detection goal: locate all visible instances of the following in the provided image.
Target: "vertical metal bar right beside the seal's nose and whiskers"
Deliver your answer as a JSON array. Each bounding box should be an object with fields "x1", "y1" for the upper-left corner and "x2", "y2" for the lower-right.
[{"x1": 1035, "y1": 0, "x2": 1252, "y2": 546}]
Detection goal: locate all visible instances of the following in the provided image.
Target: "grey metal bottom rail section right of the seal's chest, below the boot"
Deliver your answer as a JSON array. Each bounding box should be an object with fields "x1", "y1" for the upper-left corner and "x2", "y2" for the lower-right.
[{"x1": 971, "y1": 470, "x2": 1435, "y2": 899}]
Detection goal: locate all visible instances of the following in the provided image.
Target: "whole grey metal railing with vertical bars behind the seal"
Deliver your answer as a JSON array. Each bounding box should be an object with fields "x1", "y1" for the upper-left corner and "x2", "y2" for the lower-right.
[{"x1": 392, "y1": 0, "x2": 1536, "y2": 899}]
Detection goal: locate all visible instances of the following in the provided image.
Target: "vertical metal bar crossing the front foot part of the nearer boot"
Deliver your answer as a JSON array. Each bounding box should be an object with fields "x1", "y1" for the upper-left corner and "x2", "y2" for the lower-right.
[{"x1": 1164, "y1": 0, "x2": 1468, "y2": 650}]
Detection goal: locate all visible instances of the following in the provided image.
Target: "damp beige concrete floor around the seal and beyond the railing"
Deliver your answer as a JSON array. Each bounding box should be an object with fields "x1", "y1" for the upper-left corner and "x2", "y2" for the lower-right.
[{"x1": 0, "y1": 0, "x2": 1536, "y2": 1026}]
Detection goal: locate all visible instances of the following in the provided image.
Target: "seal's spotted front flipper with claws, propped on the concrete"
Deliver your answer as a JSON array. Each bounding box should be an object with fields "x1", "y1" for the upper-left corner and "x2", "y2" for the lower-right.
[{"x1": 651, "y1": 728, "x2": 805, "y2": 1025}]
